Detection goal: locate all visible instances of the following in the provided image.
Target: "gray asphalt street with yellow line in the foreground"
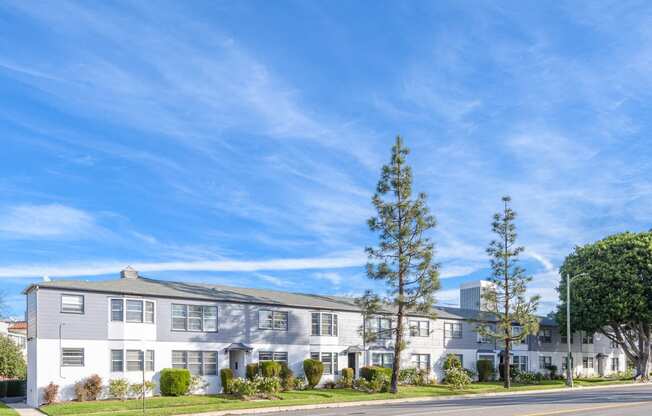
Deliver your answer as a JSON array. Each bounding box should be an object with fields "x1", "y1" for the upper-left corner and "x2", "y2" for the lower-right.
[{"x1": 252, "y1": 386, "x2": 652, "y2": 416}]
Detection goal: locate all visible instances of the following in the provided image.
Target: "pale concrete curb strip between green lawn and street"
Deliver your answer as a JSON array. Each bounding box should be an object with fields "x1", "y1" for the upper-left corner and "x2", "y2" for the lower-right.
[{"x1": 179, "y1": 383, "x2": 650, "y2": 416}]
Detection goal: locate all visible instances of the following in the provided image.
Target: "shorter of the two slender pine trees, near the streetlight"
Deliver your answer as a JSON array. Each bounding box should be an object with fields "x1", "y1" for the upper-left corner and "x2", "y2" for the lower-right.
[{"x1": 478, "y1": 196, "x2": 539, "y2": 389}]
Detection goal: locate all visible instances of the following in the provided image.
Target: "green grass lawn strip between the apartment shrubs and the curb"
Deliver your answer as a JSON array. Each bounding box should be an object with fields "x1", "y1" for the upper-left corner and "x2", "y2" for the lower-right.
[{"x1": 39, "y1": 380, "x2": 630, "y2": 416}]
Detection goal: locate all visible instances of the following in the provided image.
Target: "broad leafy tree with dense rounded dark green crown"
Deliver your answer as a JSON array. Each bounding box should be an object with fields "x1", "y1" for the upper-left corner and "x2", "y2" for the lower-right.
[{"x1": 557, "y1": 232, "x2": 652, "y2": 381}]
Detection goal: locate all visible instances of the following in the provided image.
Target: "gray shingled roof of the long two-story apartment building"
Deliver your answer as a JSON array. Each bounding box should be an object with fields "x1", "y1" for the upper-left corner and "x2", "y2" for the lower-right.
[{"x1": 24, "y1": 276, "x2": 556, "y2": 325}]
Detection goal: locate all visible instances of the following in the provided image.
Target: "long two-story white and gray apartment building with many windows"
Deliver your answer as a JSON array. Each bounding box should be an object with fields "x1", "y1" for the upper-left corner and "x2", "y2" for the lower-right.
[{"x1": 25, "y1": 269, "x2": 625, "y2": 406}]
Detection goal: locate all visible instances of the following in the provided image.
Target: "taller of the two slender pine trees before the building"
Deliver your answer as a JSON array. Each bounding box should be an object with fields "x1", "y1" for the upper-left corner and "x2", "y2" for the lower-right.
[{"x1": 367, "y1": 137, "x2": 439, "y2": 393}]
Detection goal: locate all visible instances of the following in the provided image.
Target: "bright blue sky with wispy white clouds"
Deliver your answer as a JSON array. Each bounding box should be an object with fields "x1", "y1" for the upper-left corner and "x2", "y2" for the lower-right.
[{"x1": 0, "y1": 1, "x2": 652, "y2": 315}]
